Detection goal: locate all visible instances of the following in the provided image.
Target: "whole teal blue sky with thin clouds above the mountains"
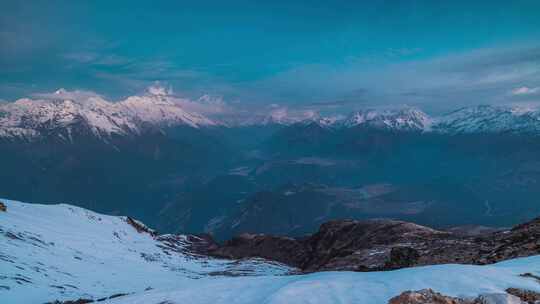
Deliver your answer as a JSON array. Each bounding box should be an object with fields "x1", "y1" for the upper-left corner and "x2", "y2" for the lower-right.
[{"x1": 0, "y1": 0, "x2": 540, "y2": 111}]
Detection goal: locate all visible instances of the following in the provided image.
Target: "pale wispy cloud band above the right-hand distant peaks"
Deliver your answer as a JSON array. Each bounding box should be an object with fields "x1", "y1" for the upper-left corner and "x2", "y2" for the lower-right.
[{"x1": 243, "y1": 45, "x2": 540, "y2": 113}]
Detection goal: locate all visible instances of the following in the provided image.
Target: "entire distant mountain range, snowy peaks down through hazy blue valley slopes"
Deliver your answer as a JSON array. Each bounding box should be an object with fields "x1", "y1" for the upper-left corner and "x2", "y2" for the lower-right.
[{"x1": 0, "y1": 90, "x2": 540, "y2": 239}]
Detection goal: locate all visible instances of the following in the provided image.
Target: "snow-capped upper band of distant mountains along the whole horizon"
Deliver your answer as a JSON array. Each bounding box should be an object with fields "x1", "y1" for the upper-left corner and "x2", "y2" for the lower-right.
[{"x1": 0, "y1": 90, "x2": 540, "y2": 141}]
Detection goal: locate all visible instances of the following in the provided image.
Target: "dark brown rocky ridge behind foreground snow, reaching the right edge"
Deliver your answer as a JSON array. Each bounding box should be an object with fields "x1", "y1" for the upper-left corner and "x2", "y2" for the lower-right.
[{"x1": 207, "y1": 218, "x2": 540, "y2": 272}]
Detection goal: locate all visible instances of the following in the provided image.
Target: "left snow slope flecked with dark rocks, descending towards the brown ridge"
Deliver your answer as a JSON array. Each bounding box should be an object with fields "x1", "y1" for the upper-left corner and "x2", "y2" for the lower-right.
[{"x1": 0, "y1": 199, "x2": 290, "y2": 304}]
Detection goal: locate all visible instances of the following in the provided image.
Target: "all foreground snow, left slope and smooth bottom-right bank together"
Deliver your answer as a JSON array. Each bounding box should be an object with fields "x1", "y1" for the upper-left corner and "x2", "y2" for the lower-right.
[{"x1": 0, "y1": 200, "x2": 540, "y2": 304}]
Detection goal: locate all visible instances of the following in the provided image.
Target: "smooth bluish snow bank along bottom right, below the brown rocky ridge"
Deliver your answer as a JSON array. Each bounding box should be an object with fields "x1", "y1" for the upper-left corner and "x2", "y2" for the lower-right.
[{"x1": 110, "y1": 256, "x2": 540, "y2": 304}]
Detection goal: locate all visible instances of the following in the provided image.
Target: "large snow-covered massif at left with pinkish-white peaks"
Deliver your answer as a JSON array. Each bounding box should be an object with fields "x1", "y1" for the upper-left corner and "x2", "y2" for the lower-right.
[{"x1": 0, "y1": 89, "x2": 217, "y2": 140}]
